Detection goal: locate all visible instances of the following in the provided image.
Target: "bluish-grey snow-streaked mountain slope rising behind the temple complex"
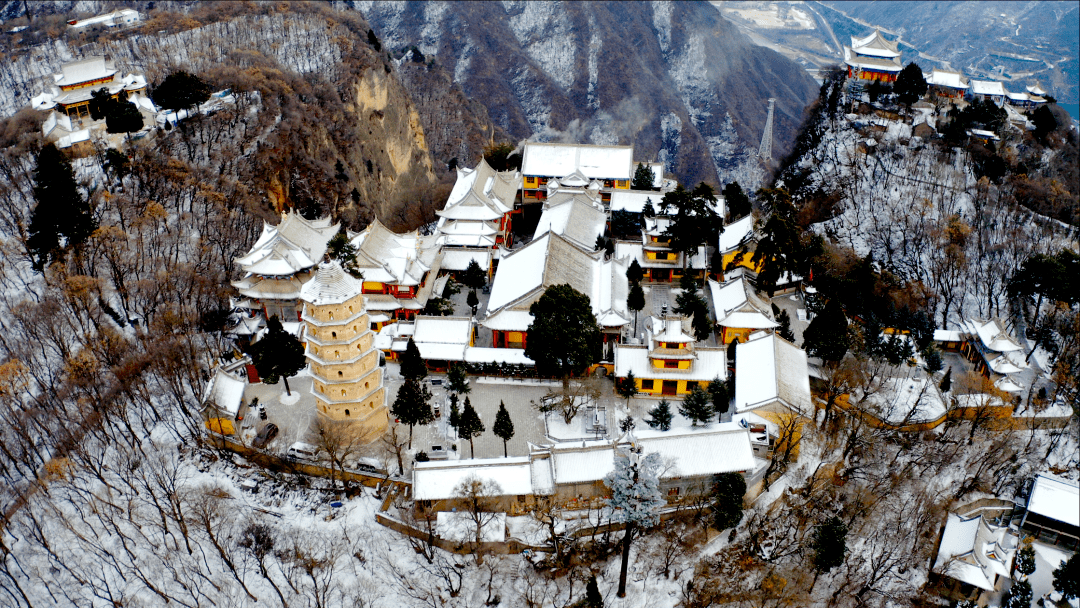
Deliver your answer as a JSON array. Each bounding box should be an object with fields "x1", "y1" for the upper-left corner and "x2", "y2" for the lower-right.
[{"x1": 352, "y1": 1, "x2": 816, "y2": 186}]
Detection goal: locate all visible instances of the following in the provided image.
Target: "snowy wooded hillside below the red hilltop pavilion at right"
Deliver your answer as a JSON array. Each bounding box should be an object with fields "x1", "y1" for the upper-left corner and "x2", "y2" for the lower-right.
[{"x1": 778, "y1": 76, "x2": 1077, "y2": 327}]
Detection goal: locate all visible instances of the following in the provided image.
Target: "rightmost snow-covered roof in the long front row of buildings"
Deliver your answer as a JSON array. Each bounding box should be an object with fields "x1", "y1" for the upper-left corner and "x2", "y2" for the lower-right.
[{"x1": 635, "y1": 422, "x2": 755, "y2": 479}]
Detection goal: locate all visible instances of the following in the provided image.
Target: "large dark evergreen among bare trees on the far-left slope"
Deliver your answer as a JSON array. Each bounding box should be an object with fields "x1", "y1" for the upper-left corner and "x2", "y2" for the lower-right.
[{"x1": 26, "y1": 144, "x2": 97, "y2": 271}]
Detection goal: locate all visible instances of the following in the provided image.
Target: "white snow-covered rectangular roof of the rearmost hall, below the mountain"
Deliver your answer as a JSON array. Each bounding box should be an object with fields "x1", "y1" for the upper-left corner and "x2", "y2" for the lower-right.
[{"x1": 522, "y1": 141, "x2": 634, "y2": 179}]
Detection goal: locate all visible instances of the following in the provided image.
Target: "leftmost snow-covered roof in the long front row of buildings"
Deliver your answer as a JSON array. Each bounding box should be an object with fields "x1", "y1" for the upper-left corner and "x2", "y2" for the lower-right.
[{"x1": 413, "y1": 457, "x2": 532, "y2": 500}]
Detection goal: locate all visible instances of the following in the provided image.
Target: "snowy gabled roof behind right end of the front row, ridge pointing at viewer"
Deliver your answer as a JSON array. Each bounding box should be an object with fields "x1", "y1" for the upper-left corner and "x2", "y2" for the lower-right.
[{"x1": 735, "y1": 334, "x2": 813, "y2": 413}]
